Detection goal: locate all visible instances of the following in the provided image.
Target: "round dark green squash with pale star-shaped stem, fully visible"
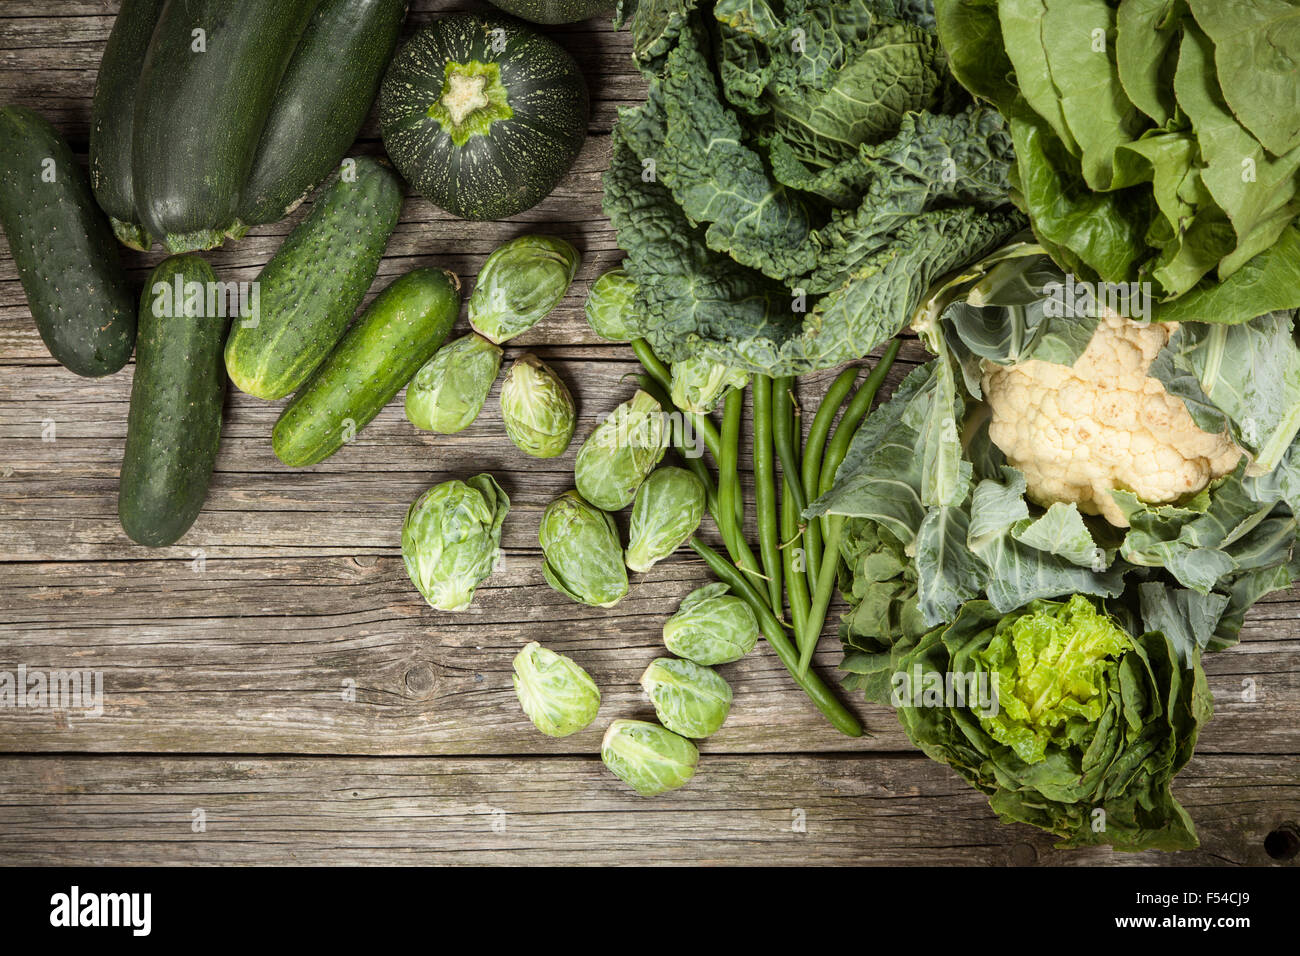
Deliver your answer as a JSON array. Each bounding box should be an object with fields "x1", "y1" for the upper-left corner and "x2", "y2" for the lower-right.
[{"x1": 380, "y1": 13, "x2": 588, "y2": 220}]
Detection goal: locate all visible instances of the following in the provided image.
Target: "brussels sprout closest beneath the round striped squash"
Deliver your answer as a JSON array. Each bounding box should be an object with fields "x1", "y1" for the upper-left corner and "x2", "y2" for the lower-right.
[{"x1": 469, "y1": 235, "x2": 581, "y2": 345}]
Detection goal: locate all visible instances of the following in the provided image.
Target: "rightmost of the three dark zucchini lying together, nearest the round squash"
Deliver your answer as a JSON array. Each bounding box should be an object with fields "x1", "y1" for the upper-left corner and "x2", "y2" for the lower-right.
[{"x1": 239, "y1": 0, "x2": 407, "y2": 225}]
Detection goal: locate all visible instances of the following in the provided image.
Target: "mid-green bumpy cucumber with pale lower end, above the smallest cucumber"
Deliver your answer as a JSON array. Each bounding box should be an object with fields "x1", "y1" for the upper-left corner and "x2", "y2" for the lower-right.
[{"x1": 226, "y1": 156, "x2": 402, "y2": 399}]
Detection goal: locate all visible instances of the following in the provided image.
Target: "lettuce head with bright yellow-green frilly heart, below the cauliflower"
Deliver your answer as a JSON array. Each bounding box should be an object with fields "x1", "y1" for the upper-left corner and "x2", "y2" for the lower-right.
[{"x1": 845, "y1": 594, "x2": 1212, "y2": 851}]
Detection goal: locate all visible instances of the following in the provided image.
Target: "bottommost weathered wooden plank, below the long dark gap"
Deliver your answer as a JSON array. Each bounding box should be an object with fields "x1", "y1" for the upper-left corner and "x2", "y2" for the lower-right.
[{"x1": 0, "y1": 754, "x2": 1300, "y2": 866}]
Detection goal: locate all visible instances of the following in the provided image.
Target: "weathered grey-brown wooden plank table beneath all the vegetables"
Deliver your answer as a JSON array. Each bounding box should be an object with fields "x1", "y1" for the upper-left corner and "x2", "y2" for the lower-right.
[{"x1": 0, "y1": 0, "x2": 1300, "y2": 864}]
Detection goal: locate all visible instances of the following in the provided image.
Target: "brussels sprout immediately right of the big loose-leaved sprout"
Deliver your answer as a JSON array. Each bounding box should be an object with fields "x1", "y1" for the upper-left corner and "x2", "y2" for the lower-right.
[{"x1": 537, "y1": 492, "x2": 628, "y2": 607}]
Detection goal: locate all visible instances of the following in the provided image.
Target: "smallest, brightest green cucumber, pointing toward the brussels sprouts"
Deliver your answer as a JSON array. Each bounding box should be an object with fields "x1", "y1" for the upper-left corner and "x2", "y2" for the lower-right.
[{"x1": 270, "y1": 269, "x2": 460, "y2": 468}]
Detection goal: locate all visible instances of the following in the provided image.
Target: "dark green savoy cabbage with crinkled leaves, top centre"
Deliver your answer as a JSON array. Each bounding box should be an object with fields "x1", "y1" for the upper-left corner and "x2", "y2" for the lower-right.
[{"x1": 605, "y1": 0, "x2": 1024, "y2": 375}]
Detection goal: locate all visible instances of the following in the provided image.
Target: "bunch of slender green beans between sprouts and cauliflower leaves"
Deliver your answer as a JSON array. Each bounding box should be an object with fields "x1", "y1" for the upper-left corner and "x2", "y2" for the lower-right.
[{"x1": 632, "y1": 339, "x2": 900, "y2": 736}]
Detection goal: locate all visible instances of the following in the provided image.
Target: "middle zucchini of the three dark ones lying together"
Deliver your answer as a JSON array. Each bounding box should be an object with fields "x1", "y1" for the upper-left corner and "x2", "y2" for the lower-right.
[{"x1": 131, "y1": 0, "x2": 316, "y2": 252}]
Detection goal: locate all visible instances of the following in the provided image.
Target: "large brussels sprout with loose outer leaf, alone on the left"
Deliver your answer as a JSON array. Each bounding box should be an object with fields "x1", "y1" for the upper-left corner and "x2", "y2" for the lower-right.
[{"x1": 402, "y1": 475, "x2": 510, "y2": 611}]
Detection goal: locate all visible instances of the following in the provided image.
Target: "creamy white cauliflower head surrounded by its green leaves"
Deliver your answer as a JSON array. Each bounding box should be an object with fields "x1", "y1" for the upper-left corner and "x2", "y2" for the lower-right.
[{"x1": 983, "y1": 312, "x2": 1242, "y2": 528}]
